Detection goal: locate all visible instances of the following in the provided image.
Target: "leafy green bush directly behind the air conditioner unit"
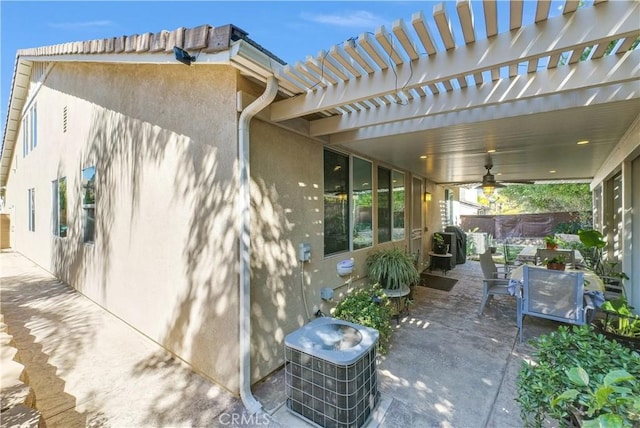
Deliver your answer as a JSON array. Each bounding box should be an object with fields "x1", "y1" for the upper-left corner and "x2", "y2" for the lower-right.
[{"x1": 333, "y1": 284, "x2": 392, "y2": 355}]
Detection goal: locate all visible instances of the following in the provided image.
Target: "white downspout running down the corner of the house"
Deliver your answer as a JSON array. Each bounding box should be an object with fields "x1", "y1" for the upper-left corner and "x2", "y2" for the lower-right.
[{"x1": 238, "y1": 76, "x2": 278, "y2": 414}]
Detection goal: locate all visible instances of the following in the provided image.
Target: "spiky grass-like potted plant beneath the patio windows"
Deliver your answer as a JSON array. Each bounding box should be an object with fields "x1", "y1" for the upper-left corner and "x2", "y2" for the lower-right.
[{"x1": 367, "y1": 247, "x2": 420, "y2": 290}]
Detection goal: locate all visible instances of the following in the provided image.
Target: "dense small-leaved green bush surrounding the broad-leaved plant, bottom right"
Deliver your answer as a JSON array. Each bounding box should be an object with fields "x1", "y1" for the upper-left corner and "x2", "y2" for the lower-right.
[{"x1": 516, "y1": 326, "x2": 640, "y2": 427}]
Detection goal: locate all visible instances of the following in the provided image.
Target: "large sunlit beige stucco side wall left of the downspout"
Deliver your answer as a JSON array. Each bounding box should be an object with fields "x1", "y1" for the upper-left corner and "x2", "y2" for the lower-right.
[{"x1": 7, "y1": 63, "x2": 244, "y2": 393}]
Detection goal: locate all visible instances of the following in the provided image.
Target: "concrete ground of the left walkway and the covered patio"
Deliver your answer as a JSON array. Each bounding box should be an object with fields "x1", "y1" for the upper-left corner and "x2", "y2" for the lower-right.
[{"x1": 0, "y1": 251, "x2": 558, "y2": 428}]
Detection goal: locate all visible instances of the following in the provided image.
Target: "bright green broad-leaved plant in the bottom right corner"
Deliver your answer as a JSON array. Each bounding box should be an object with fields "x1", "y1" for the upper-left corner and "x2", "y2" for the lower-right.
[{"x1": 551, "y1": 366, "x2": 640, "y2": 428}]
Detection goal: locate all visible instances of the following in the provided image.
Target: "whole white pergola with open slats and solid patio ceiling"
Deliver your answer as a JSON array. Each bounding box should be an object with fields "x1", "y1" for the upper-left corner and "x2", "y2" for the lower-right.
[{"x1": 241, "y1": 0, "x2": 640, "y2": 187}]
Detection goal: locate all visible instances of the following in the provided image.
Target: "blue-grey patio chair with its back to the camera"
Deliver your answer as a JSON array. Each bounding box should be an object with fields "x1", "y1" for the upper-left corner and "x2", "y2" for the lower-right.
[{"x1": 516, "y1": 265, "x2": 594, "y2": 342}]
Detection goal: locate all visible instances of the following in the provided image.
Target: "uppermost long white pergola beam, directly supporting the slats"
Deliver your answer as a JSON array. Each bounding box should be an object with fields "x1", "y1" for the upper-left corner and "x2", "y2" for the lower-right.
[{"x1": 271, "y1": 2, "x2": 640, "y2": 121}]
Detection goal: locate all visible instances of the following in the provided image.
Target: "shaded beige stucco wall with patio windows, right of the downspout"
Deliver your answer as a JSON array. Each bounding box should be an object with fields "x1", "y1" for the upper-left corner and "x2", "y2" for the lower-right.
[{"x1": 251, "y1": 120, "x2": 438, "y2": 381}]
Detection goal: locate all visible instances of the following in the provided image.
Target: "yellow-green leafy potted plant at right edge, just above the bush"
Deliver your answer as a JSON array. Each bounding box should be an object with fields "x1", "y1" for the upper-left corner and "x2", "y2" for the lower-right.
[{"x1": 594, "y1": 296, "x2": 640, "y2": 351}]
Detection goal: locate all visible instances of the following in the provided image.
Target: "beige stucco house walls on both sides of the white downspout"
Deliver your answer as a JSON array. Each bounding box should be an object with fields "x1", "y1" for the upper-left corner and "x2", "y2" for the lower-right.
[{"x1": 7, "y1": 63, "x2": 452, "y2": 393}]
